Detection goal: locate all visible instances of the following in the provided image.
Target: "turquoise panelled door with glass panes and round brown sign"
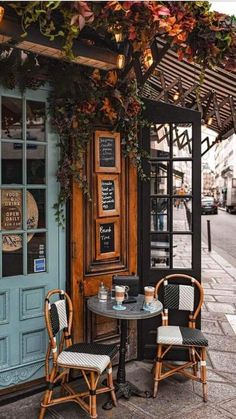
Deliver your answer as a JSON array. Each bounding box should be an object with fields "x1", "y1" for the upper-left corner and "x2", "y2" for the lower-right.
[{"x1": 0, "y1": 89, "x2": 65, "y2": 391}]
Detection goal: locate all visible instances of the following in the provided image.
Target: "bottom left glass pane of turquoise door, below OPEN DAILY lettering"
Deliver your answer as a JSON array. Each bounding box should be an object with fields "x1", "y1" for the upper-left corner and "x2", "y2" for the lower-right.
[{"x1": 2, "y1": 234, "x2": 23, "y2": 276}]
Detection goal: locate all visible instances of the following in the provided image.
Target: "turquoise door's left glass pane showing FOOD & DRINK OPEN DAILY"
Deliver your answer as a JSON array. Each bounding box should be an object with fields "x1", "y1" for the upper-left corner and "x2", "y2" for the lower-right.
[{"x1": 1, "y1": 189, "x2": 23, "y2": 230}]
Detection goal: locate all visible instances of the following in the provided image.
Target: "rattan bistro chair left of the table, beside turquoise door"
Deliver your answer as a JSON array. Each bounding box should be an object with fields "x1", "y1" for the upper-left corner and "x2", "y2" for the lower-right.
[{"x1": 39, "y1": 289, "x2": 117, "y2": 419}]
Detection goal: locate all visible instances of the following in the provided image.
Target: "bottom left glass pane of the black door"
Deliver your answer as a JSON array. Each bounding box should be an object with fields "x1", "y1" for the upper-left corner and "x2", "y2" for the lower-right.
[{"x1": 150, "y1": 234, "x2": 170, "y2": 269}]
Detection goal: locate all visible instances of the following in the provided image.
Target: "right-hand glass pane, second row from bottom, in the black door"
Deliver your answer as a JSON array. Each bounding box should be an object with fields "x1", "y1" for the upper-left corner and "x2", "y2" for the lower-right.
[{"x1": 173, "y1": 198, "x2": 192, "y2": 231}]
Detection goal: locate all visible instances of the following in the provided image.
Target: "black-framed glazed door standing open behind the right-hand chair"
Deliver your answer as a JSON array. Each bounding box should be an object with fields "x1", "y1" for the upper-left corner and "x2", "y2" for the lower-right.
[{"x1": 139, "y1": 100, "x2": 201, "y2": 359}]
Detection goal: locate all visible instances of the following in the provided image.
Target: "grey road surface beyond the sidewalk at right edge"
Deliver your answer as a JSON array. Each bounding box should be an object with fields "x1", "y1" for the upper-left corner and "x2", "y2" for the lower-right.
[{"x1": 202, "y1": 210, "x2": 236, "y2": 268}]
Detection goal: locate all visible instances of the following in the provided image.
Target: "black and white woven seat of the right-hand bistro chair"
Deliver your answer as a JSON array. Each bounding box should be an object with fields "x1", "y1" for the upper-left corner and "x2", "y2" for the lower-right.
[{"x1": 157, "y1": 326, "x2": 208, "y2": 346}]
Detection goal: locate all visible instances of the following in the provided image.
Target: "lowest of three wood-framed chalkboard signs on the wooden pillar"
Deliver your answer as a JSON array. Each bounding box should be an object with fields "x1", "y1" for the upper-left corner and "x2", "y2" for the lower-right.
[{"x1": 96, "y1": 217, "x2": 120, "y2": 260}]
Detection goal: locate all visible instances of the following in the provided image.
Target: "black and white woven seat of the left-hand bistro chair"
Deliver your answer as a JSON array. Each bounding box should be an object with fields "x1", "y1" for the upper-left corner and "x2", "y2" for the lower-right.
[{"x1": 57, "y1": 343, "x2": 117, "y2": 374}]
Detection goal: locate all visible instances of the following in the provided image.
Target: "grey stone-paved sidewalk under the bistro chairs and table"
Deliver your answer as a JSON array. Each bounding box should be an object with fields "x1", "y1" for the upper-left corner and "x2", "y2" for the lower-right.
[{"x1": 0, "y1": 244, "x2": 236, "y2": 419}]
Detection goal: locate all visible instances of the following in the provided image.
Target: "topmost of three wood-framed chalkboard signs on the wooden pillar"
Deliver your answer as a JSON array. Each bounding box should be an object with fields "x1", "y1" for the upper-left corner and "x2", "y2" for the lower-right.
[{"x1": 95, "y1": 131, "x2": 120, "y2": 173}]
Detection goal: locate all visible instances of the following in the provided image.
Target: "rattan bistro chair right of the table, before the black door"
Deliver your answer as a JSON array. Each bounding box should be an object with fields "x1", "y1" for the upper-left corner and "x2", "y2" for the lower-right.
[{"x1": 153, "y1": 274, "x2": 208, "y2": 401}]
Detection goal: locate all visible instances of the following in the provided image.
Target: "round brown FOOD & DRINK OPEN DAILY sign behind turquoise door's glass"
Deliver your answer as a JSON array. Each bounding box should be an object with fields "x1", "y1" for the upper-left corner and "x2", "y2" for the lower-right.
[{"x1": 1, "y1": 189, "x2": 39, "y2": 252}]
